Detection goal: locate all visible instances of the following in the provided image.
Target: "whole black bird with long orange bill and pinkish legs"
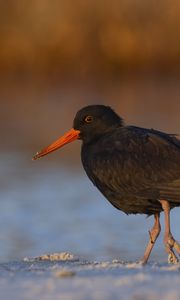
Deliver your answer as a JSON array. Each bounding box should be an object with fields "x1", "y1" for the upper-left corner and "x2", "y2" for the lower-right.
[{"x1": 33, "y1": 105, "x2": 180, "y2": 264}]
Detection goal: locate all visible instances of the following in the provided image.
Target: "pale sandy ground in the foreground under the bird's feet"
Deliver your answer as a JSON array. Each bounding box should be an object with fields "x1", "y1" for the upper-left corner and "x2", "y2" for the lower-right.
[{"x1": 0, "y1": 253, "x2": 180, "y2": 300}]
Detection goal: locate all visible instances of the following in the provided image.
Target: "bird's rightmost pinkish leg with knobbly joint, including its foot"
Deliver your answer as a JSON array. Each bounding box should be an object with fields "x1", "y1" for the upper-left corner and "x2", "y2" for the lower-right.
[{"x1": 159, "y1": 200, "x2": 180, "y2": 263}]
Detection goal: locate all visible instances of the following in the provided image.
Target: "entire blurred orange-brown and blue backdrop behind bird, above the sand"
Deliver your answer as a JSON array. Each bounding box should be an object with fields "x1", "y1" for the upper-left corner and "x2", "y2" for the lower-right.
[{"x1": 0, "y1": 0, "x2": 180, "y2": 261}]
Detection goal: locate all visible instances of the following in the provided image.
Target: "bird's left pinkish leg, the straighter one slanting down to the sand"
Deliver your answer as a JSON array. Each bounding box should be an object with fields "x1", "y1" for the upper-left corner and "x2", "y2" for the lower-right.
[{"x1": 140, "y1": 213, "x2": 161, "y2": 265}]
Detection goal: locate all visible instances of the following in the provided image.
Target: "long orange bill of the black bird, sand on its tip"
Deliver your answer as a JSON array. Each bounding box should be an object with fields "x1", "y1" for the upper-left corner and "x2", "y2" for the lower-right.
[{"x1": 33, "y1": 128, "x2": 80, "y2": 160}]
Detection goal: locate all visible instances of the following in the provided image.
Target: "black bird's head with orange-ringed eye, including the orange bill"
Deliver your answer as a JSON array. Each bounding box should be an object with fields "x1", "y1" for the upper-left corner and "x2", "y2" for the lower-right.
[{"x1": 33, "y1": 105, "x2": 123, "y2": 160}]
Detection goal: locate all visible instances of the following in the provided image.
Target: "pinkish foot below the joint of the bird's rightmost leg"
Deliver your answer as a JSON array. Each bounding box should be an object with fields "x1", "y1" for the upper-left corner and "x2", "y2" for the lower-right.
[{"x1": 165, "y1": 235, "x2": 180, "y2": 264}]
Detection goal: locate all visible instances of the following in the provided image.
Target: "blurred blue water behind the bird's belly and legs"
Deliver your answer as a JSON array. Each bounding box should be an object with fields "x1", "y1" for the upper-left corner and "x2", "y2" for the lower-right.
[{"x1": 0, "y1": 153, "x2": 180, "y2": 261}]
